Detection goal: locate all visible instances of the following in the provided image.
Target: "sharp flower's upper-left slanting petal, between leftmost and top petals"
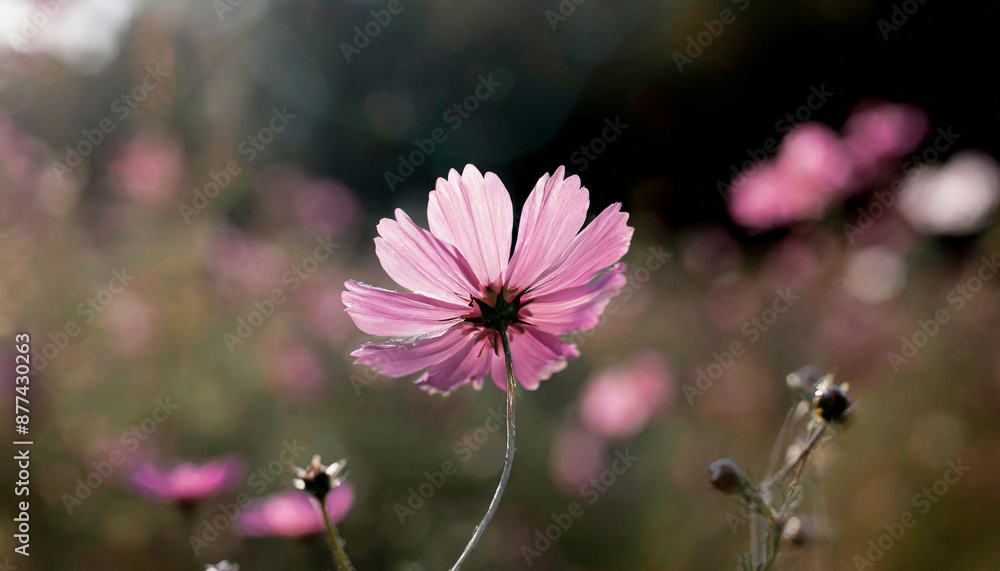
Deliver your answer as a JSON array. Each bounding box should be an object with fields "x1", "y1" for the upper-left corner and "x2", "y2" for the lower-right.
[{"x1": 375, "y1": 208, "x2": 480, "y2": 304}]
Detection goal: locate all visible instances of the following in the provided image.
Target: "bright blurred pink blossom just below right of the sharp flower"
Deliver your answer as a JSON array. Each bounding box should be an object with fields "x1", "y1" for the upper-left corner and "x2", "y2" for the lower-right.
[{"x1": 580, "y1": 351, "x2": 674, "y2": 439}]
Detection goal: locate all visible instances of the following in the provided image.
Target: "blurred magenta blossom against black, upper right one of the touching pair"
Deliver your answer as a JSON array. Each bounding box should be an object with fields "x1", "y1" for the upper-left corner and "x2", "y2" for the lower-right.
[{"x1": 842, "y1": 100, "x2": 930, "y2": 180}]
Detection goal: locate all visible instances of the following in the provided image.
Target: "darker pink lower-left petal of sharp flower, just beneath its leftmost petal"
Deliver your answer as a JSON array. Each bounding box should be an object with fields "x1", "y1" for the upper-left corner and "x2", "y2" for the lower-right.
[{"x1": 351, "y1": 323, "x2": 477, "y2": 377}]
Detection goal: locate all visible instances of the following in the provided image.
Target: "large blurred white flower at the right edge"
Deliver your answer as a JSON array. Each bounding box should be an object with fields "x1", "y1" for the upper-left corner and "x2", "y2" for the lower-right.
[{"x1": 899, "y1": 151, "x2": 1000, "y2": 235}]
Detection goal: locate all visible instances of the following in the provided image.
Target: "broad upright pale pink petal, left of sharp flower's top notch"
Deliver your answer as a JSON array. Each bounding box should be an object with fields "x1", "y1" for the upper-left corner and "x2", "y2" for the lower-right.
[{"x1": 427, "y1": 165, "x2": 514, "y2": 286}]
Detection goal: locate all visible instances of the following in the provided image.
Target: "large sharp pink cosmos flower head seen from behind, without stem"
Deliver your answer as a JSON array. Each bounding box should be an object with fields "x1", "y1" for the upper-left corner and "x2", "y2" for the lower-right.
[{"x1": 342, "y1": 165, "x2": 632, "y2": 392}]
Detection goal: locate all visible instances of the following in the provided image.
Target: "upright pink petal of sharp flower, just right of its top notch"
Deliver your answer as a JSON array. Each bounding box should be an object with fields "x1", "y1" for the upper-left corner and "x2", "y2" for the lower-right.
[{"x1": 507, "y1": 167, "x2": 590, "y2": 292}]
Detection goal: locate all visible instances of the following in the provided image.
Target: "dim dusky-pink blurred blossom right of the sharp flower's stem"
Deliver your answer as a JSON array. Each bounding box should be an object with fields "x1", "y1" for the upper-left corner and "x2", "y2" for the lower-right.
[{"x1": 549, "y1": 428, "x2": 607, "y2": 495}]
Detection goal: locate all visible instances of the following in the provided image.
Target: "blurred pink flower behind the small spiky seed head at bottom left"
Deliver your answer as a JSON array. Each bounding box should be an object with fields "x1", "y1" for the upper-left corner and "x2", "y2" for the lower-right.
[{"x1": 235, "y1": 482, "x2": 354, "y2": 538}]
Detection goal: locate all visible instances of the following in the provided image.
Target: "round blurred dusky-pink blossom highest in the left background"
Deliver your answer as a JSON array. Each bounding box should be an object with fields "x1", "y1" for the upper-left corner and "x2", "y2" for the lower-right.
[{"x1": 110, "y1": 131, "x2": 184, "y2": 206}]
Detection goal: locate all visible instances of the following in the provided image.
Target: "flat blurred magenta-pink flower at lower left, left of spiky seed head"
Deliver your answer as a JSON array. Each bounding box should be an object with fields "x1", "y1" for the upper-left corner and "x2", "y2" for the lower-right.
[{"x1": 131, "y1": 457, "x2": 244, "y2": 504}]
